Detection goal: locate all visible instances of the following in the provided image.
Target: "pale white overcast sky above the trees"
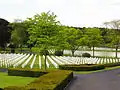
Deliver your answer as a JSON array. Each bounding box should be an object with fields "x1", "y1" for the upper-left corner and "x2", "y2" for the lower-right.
[{"x1": 0, "y1": 0, "x2": 120, "y2": 27}]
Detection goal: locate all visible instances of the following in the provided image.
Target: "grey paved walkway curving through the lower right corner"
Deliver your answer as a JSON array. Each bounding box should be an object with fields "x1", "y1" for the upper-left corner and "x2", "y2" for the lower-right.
[{"x1": 65, "y1": 69, "x2": 120, "y2": 90}]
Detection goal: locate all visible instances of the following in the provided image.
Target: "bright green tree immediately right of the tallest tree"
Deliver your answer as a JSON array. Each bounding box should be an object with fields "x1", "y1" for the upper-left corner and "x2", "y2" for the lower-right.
[{"x1": 63, "y1": 27, "x2": 83, "y2": 56}]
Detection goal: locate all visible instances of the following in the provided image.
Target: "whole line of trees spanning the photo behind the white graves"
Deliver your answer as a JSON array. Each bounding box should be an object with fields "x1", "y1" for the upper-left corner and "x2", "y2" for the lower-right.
[{"x1": 0, "y1": 12, "x2": 120, "y2": 58}]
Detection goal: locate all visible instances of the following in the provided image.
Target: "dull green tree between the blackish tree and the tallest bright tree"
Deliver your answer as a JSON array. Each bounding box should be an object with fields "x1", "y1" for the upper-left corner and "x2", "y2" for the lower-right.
[{"x1": 11, "y1": 19, "x2": 28, "y2": 52}]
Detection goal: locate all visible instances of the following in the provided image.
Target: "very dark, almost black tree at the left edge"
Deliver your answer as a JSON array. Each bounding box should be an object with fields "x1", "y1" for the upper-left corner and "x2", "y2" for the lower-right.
[{"x1": 0, "y1": 18, "x2": 11, "y2": 49}]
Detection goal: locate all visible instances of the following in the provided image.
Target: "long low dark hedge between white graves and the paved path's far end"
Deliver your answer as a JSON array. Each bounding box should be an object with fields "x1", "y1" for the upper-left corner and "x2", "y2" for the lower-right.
[{"x1": 59, "y1": 64, "x2": 105, "y2": 71}]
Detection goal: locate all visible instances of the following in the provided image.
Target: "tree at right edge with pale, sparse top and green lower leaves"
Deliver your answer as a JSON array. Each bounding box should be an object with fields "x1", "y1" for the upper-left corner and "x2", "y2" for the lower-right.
[{"x1": 105, "y1": 20, "x2": 120, "y2": 58}]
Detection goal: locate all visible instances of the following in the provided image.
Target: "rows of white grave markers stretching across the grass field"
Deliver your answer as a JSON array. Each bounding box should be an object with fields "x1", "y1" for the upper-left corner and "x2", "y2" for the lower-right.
[{"x1": 0, "y1": 54, "x2": 120, "y2": 69}]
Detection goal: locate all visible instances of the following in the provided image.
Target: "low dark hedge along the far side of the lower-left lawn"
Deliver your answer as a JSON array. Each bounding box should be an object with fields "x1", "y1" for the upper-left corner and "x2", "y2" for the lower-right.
[{"x1": 8, "y1": 68, "x2": 48, "y2": 77}]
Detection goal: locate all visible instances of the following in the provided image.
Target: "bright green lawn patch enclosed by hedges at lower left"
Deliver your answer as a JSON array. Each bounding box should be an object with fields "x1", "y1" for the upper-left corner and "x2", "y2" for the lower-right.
[{"x1": 0, "y1": 72, "x2": 36, "y2": 88}]
